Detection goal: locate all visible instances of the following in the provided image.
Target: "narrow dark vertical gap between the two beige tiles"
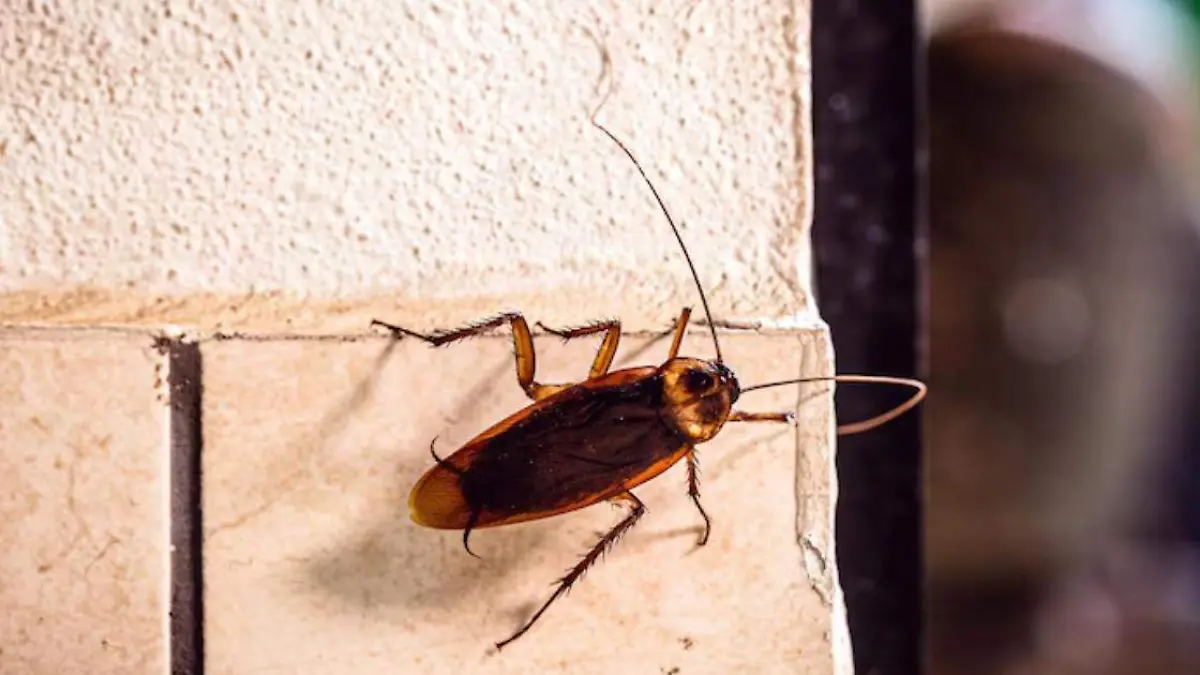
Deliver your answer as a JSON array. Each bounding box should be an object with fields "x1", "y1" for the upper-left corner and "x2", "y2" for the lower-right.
[{"x1": 161, "y1": 340, "x2": 204, "y2": 675}]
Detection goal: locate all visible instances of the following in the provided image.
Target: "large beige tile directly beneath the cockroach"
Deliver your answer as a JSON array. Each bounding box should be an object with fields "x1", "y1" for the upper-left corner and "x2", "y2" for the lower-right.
[{"x1": 204, "y1": 331, "x2": 840, "y2": 674}]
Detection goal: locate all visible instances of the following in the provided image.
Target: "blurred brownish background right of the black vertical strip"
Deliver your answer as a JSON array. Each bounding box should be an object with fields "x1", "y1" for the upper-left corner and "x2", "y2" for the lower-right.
[{"x1": 923, "y1": 0, "x2": 1200, "y2": 675}]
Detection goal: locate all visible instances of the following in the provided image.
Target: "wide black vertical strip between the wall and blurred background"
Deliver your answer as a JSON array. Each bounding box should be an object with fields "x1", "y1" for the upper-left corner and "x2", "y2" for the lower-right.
[{"x1": 812, "y1": 0, "x2": 924, "y2": 675}]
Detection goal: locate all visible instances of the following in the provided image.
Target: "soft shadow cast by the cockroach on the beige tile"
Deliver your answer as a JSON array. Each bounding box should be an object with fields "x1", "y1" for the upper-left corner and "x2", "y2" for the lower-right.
[{"x1": 299, "y1": 330, "x2": 671, "y2": 616}]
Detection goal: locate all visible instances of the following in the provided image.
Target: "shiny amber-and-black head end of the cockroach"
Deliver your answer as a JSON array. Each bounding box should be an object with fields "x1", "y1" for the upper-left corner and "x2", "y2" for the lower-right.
[{"x1": 661, "y1": 358, "x2": 742, "y2": 443}]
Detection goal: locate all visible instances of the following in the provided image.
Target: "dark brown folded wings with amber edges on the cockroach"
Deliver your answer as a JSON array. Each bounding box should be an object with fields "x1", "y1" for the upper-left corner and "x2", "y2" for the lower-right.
[{"x1": 408, "y1": 366, "x2": 691, "y2": 530}]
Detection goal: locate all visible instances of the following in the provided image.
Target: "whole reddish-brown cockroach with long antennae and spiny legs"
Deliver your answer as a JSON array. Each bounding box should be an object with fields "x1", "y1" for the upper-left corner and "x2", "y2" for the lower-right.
[{"x1": 372, "y1": 120, "x2": 925, "y2": 649}]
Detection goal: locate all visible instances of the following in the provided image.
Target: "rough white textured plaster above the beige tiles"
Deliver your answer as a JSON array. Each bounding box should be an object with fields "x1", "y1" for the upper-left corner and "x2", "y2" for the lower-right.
[{"x1": 0, "y1": 0, "x2": 810, "y2": 330}]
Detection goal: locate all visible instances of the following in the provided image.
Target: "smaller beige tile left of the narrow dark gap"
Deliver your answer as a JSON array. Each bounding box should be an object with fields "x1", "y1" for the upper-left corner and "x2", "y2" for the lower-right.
[{"x1": 0, "y1": 334, "x2": 167, "y2": 675}]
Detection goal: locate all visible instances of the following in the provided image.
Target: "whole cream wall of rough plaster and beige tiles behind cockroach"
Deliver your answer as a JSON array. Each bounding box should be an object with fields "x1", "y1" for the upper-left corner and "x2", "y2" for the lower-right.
[{"x1": 0, "y1": 0, "x2": 848, "y2": 674}]
